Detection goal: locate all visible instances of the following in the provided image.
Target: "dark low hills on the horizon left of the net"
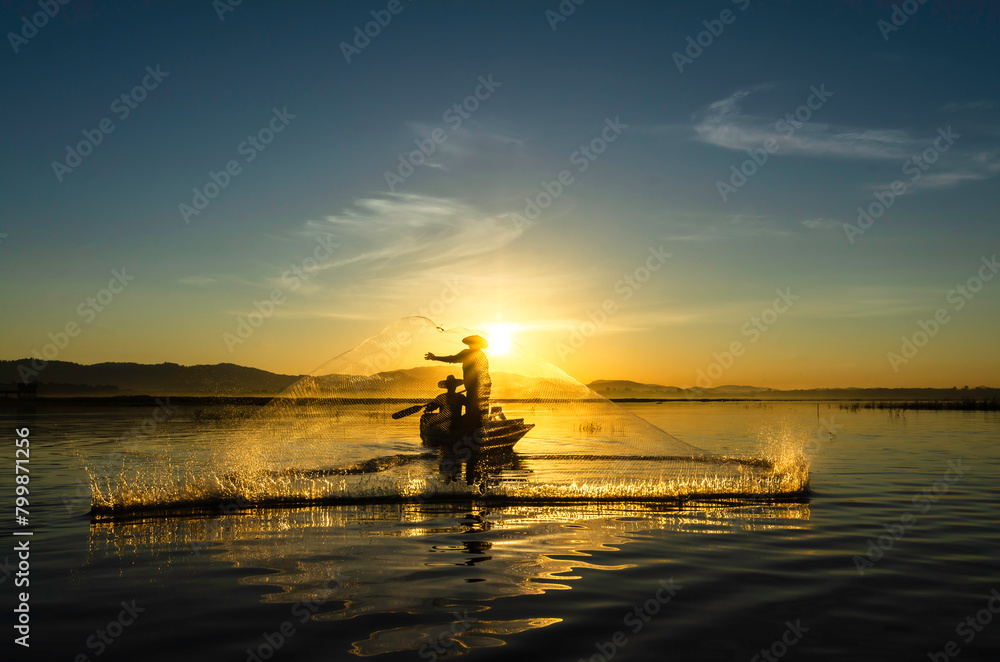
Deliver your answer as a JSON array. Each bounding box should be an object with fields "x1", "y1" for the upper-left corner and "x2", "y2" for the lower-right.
[{"x1": 0, "y1": 359, "x2": 298, "y2": 396}]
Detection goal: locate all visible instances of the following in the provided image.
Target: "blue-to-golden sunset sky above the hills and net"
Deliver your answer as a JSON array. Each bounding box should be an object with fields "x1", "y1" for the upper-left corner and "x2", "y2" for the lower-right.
[{"x1": 0, "y1": 0, "x2": 1000, "y2": 388}]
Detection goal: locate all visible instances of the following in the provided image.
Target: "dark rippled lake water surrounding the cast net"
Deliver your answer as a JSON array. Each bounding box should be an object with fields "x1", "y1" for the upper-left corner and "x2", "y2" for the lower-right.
[{"x1": 0, "y1": 402, "x2": 1000, "y2": 661}]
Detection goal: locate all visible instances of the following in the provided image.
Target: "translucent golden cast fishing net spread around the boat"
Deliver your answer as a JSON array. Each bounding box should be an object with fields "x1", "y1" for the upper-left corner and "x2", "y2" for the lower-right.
[{"x1": 92, "y1": 317, "x2": 808, "y2": 514}]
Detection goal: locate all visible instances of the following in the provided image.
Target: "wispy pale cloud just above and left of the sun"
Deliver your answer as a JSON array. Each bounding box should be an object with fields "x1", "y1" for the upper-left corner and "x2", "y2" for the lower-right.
[{"x1": 224, "y1": 193, "x2": 551, "y2": 320}]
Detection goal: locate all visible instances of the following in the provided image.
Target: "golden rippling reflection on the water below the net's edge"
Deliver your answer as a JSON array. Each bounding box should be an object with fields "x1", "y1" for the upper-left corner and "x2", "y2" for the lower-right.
[{"x1": 88, "y1": 502, "x2": 809, "y2": 657}]
